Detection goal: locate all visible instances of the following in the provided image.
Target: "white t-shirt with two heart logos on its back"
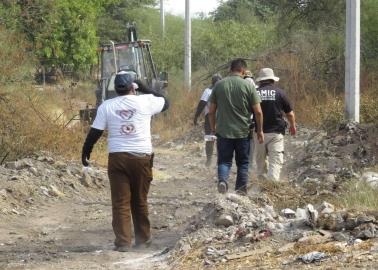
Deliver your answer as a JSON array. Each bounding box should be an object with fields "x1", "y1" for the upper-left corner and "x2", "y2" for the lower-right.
[{"x1": 92, "y1": 94, "x2": 165, "y2": 154}]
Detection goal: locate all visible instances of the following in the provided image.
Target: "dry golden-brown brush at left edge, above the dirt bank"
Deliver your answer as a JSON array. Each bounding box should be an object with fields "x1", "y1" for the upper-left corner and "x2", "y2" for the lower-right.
[{"x1": 0, "y1": 85, "x2": 88, "y2": 160}]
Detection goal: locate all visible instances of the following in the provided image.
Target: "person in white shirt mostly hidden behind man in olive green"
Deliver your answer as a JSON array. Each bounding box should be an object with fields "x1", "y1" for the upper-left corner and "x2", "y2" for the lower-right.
[{"x1": 194, "y1": 74, "x2": 222, "y2": 166}]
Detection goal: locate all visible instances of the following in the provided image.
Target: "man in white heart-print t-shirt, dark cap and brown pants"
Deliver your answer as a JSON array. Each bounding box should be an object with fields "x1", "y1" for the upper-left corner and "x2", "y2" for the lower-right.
[{"x1": 82, "y1": 72, "x2": 169, "y2": 252}]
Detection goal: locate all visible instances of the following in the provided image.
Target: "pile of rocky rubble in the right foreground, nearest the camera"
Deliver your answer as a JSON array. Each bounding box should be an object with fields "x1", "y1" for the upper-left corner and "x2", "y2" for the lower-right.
[{"x1": 170, "y1": 193, "x2": 378, "y2": 265}]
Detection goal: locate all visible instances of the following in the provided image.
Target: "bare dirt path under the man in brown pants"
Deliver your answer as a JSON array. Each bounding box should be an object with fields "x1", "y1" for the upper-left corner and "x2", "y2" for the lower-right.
[{"x1": 0, "y1": 146, "x2": 214, "y2": 269}]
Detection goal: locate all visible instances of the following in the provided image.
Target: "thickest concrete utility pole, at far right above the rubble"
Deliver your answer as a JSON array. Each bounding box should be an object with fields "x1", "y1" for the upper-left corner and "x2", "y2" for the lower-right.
[{"x1": 345, "y1": 0, "x2": 360, "y2": 122}]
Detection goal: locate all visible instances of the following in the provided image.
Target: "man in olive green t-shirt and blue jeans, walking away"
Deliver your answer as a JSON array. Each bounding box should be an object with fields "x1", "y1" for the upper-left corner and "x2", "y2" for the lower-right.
[{"x1": 209, "y1": 59, "x2": 264, "y2": 194}]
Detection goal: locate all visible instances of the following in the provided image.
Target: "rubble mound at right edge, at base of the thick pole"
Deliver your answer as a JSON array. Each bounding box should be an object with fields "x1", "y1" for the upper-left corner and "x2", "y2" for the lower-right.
[{"x1": 289, "y1": 123, "x2": 378, "y2": 194}]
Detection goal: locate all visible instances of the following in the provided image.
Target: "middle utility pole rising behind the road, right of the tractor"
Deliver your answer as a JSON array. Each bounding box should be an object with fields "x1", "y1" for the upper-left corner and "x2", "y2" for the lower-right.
[{"x1": 184, "y1": 0, "x2": 192, "y2": 90}]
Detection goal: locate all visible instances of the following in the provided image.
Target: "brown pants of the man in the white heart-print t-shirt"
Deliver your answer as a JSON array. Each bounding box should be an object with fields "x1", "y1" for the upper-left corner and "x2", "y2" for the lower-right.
[{"x1": 108, "y1": 153, "x2": 152, "y2": 246}]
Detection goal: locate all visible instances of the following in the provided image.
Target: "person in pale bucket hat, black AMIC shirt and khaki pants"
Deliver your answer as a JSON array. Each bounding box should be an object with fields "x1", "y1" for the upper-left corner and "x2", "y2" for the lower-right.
[{"x1": 254, "y1": 68, "x2": 296, "y2": 181}]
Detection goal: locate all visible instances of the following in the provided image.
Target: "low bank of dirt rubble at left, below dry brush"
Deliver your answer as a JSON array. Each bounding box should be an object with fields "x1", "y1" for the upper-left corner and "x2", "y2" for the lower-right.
[{"x1": 0, "y1": 153, "x2": 108, "y2": 215}]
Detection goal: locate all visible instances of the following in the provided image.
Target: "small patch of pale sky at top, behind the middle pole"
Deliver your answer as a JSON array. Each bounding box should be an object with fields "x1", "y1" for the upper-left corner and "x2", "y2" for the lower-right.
[{"x1": 164, "y1": 0, "x2": 218, "y2": 16}]
